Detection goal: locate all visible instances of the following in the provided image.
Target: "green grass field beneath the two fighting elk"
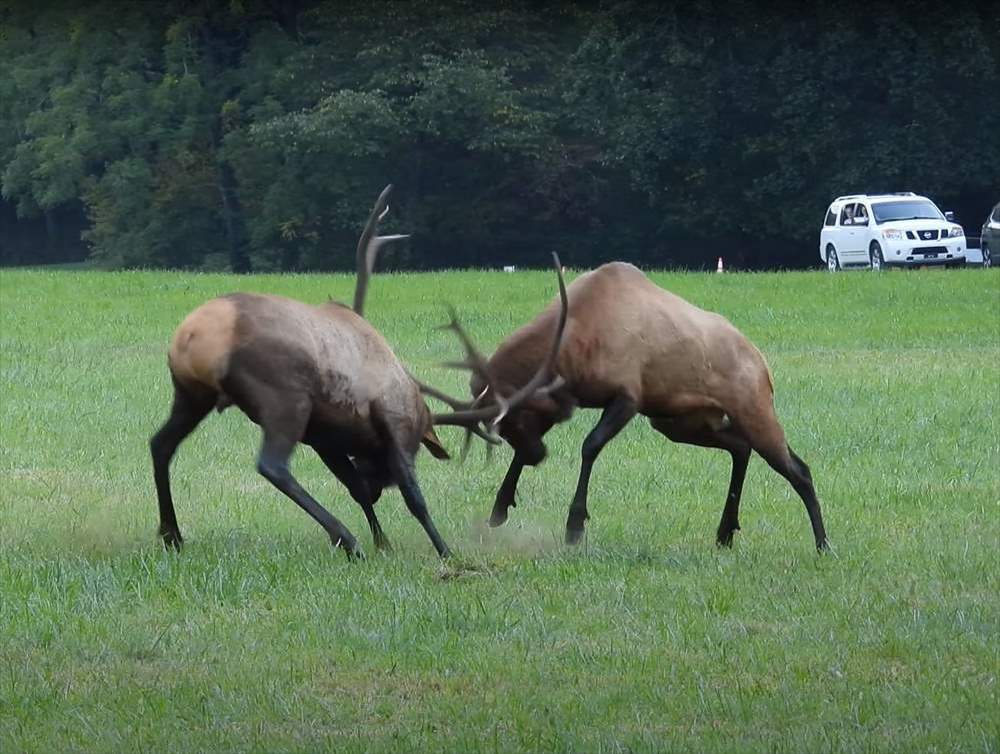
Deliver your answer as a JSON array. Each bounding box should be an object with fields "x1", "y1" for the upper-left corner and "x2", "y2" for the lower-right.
[{"x1": 0, "y1": 270, "x2": 1000, "y2": 752}]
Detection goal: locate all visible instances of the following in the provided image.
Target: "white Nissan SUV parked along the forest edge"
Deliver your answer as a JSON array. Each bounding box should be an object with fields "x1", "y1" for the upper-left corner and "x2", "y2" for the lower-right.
[{"x1": 819, "y1": 191, "x2": 965, "y2": 272}]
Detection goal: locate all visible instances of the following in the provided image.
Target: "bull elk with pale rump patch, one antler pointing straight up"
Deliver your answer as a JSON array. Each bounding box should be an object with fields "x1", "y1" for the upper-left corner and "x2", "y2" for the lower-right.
[{"x1": 150, "y1": 186, "x2": 492, "y2": 557}]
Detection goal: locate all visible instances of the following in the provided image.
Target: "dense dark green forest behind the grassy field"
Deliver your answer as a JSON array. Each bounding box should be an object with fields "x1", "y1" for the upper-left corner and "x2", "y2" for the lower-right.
[{"x1": 0, "y1": 0, "x2": 1000, "y2": 272}]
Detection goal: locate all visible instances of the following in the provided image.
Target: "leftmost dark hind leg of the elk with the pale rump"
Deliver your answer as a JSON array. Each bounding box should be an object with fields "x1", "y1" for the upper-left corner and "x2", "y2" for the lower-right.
[{"x1": 149, "y1": 382, "x2": 215, "y2": 550}]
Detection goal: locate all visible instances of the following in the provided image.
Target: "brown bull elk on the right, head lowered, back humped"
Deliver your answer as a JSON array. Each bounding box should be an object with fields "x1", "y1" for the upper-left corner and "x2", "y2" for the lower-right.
[{"x1": 435, "y1": 262, "x2": 827, "y2": 549}]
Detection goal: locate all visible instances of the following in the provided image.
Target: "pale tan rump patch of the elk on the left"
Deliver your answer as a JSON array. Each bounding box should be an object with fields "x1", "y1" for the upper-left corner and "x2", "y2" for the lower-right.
[{"x1": 167, "y1": 298, "x2": 237, "y2": 391}]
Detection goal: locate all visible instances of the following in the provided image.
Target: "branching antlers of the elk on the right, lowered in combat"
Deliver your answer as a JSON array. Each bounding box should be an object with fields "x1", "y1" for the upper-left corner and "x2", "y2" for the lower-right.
[{"x1": 421, "y1": 252, "x2": 569, "y2": 434}]
